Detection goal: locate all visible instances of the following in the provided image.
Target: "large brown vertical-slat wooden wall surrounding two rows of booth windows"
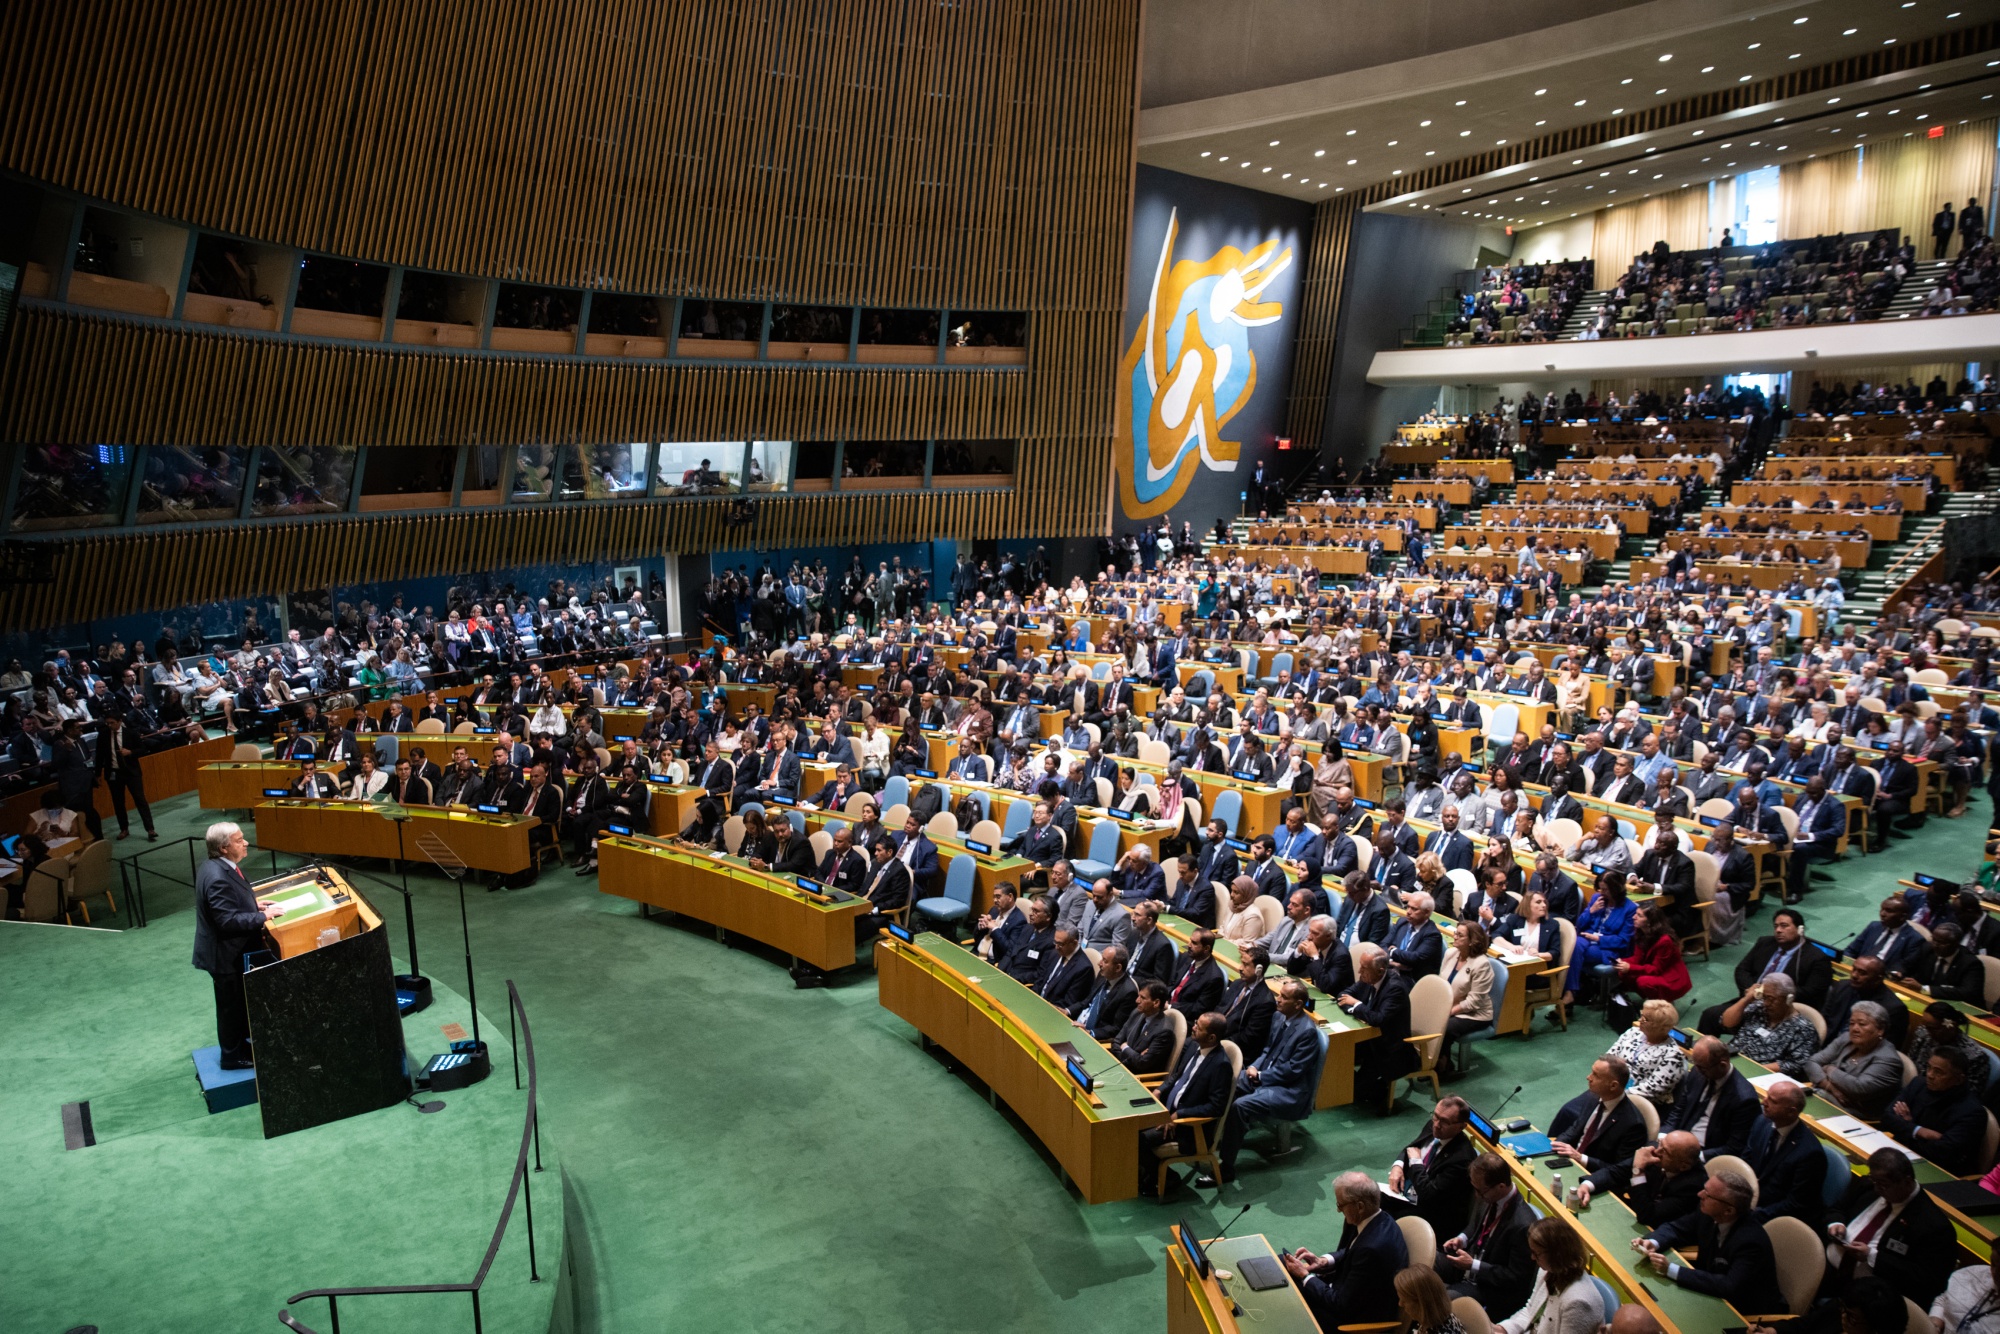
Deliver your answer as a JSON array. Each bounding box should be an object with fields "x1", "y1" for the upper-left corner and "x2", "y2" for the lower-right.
[{"x1": 0, "y1": 0, "x2": 1138, "y2": 628}]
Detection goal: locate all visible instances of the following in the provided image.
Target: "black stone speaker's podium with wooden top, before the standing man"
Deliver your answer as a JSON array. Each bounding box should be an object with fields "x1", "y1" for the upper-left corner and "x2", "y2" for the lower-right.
[{"x1": 244, "y1": 866, "x2": 410, "y2": 1140}]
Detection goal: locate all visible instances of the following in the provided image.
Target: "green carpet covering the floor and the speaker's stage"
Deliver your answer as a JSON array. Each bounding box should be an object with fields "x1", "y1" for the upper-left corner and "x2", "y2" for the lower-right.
[{"x1": 0, "y1": 798, "x2": 1986, "y2": 1334}]
